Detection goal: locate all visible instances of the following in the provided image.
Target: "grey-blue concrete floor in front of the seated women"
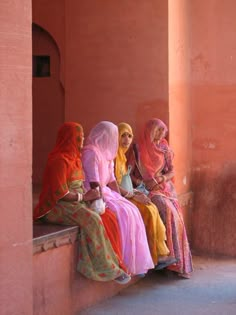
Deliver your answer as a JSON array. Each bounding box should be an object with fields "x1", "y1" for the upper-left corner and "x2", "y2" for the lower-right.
[{"x1": 79, "y1": 256, "x2": 236, "y2": 315}]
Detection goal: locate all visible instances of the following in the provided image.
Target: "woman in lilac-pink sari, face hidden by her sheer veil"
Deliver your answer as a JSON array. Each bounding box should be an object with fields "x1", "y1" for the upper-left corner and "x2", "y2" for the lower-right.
[{"x1": 82, "y1": 121, "x2": 154, "y2": 275}]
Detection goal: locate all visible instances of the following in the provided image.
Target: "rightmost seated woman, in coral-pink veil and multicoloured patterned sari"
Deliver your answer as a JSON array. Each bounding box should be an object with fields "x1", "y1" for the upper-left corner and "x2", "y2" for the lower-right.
[{"x1": 130, "y1": 118, "x2": 193, "y2": 278}]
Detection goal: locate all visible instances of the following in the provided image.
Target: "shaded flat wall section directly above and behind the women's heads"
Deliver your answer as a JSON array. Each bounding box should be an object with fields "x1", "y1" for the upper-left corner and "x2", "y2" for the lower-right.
[{"x1": 65, "y1": 0, "x2": 168, "y2": 137}]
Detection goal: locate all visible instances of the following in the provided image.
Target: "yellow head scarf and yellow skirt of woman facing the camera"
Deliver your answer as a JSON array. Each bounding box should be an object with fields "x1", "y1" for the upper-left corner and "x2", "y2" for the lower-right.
[{"x1": 115, "y1": 123, "x2": 169, "y2": 265}]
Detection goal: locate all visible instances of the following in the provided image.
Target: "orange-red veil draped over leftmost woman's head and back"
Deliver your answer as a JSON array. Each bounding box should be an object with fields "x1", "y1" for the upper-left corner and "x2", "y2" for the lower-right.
[{"x1": 34, "y1": 122, "x2": 84, "y2": 219}]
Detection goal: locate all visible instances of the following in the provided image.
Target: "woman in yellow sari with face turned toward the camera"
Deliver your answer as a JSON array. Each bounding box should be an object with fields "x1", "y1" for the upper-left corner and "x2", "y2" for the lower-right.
[{"x1": 115, "y1": 123, "x2": 176, "y2": 269}]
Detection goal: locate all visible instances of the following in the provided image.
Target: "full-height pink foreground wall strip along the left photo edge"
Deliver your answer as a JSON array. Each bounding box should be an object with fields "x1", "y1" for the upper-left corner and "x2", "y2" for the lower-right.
[{"x1": 0, "y1": 0, "x2": 32, "y2": 315}]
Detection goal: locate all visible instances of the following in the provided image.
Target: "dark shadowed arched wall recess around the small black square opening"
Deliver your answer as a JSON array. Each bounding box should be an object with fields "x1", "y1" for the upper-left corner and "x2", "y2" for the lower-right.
[{"x1": 32, "y1": 0, "x2": 65, "y2": 184}]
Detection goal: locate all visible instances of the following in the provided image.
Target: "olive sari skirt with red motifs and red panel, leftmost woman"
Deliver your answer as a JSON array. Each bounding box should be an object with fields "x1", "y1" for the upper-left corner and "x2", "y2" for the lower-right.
[{"x1": 45, "y1": 181, "x2": 126, "y2": 281}]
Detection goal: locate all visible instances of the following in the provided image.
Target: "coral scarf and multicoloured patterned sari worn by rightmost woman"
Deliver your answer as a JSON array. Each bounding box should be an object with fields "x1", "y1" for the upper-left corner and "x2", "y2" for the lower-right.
[{"x1": 132, "y1": 119, "x2": 193, "y2": 273}]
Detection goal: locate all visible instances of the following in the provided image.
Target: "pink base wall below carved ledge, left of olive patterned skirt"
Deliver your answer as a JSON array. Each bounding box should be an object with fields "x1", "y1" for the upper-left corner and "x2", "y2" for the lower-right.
[{"x1": 33, "y1": 246, "x2": 73, "y2": 315}]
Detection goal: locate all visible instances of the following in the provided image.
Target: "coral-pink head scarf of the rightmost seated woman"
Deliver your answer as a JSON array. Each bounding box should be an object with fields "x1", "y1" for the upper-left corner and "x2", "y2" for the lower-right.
[{"x1": 139, "y1": 118, "x2": 168, "y2": 179}]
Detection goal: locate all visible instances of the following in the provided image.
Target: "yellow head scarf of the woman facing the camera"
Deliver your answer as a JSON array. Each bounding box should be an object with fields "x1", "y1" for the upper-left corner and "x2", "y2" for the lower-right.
[{"x1": 115, "y1": 122, "x2": 133, "y2": 184}]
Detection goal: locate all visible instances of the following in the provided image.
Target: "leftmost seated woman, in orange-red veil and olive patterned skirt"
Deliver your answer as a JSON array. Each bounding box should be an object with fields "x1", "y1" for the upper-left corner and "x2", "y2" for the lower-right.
[{"x1": 34, "y1": 122, "x2": 130, "y2": 284}]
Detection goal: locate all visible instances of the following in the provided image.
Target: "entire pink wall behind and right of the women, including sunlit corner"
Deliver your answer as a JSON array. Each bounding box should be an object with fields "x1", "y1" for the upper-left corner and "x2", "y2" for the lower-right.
[{"x1": 30, "y1": 0, "x2": 236, "y2": 255}]
